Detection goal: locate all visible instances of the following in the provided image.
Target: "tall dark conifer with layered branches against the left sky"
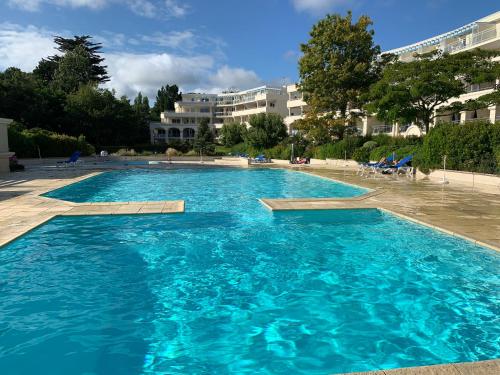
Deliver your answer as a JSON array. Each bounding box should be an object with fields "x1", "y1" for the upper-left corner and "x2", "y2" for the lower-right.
[{"x1": 48, "y1": 35, "x2": 109, "y2": 83}]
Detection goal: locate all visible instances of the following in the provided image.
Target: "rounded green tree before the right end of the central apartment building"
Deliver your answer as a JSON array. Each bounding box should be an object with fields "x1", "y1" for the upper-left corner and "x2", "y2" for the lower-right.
[{"x1": 246, "y1": 113, "x2": 287, "y2": 149}]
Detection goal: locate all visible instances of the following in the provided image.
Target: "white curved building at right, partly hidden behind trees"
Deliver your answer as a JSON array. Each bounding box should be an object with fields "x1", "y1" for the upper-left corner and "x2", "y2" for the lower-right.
[{"x1": 285, "y1": 11, "x2": 500, "y2": 136}]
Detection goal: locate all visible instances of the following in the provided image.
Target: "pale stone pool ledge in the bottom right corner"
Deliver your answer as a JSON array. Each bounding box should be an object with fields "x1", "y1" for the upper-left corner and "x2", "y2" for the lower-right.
[{"x1": 339, "y1": 359, "x2": 500, "y2": 375}]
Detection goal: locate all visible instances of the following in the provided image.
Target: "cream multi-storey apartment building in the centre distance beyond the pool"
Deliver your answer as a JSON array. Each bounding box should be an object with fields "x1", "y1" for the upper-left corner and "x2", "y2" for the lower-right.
[{"x1": 150, "y1": 86, "x2": 288, "y2": 144}]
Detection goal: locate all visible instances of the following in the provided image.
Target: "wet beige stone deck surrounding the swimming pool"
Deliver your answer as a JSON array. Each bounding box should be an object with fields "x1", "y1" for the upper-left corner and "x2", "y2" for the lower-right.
[{"x1": 0, "y1": 163, "x2": 500, "y2": 375}]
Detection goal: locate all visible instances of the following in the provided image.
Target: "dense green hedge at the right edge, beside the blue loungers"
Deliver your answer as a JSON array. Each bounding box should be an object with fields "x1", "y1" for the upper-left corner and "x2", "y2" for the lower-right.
[{"x1": 415, "y1": 121, "x2": 500, "y2": 173}]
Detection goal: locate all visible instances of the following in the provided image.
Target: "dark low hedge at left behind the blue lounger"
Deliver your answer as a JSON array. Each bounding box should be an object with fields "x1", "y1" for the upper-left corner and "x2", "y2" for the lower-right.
[{"x1": 8, "y1": 125, "x2": 95, "y2": 158}]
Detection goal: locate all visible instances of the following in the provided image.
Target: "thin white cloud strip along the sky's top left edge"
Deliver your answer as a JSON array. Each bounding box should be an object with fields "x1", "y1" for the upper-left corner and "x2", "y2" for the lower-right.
[{"x1": 8, "y1": 0, "x2": 189, "y2": 18}]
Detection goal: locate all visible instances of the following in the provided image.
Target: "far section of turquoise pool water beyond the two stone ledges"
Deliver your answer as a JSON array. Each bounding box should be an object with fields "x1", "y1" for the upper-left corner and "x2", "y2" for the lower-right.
[{"x1": 46, "y1": 168, "x2": 368, "y2": 212}]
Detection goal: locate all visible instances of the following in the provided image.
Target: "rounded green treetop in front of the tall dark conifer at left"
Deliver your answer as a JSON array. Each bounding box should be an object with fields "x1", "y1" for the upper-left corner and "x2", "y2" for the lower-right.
[{"x1": 53, "y1": 46, "x2": 94, "y2": 93}]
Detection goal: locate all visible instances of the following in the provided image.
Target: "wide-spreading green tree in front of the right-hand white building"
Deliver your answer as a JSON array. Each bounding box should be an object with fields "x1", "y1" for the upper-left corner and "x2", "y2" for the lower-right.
[{"x1": 366, "y1": 50, "x2": 499, "y2": 131}]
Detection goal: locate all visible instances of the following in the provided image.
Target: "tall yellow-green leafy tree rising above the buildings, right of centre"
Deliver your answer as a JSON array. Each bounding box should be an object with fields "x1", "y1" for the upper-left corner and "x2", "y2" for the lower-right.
[{"x1": 299, "y1": 12, "x2": 385, "y2": 118}]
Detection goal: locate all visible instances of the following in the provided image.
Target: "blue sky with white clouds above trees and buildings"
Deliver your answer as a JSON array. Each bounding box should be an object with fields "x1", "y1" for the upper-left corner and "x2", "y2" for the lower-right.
[{"x1": 0, "y1": 0, "x2": 500, "y2": 97}]
